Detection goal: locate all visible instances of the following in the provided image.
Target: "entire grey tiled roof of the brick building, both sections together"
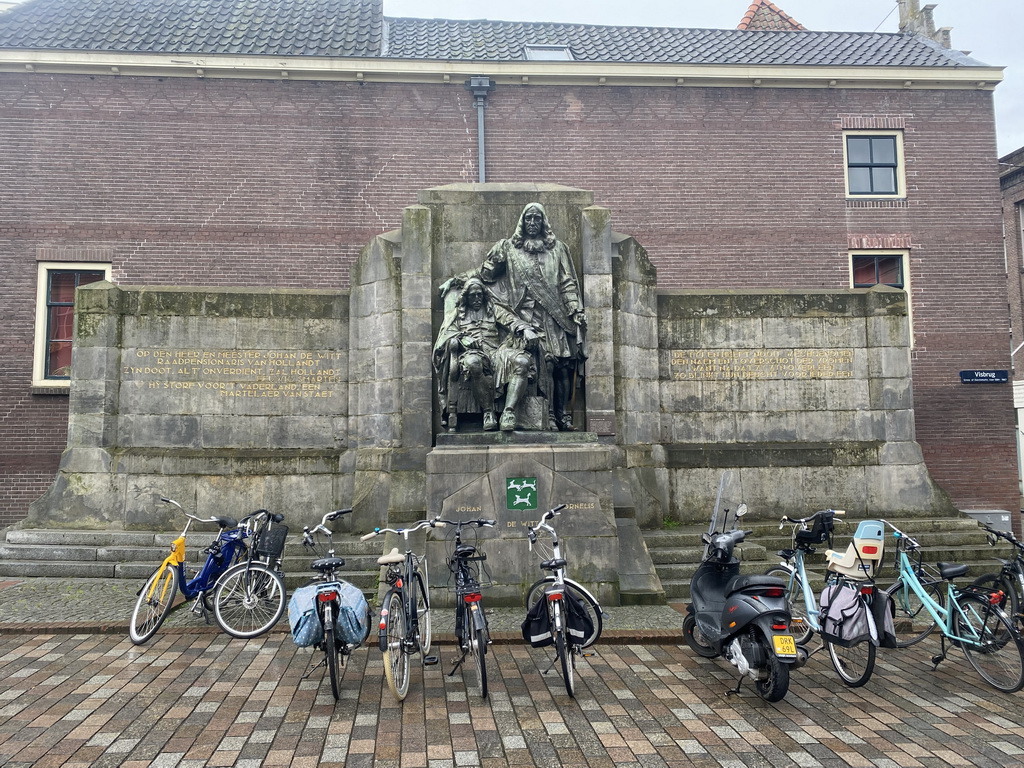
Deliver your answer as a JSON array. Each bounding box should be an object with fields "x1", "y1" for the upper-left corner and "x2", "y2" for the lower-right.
[{"x1": 0, "y1": 0, "x2": 984, "y2": 68}]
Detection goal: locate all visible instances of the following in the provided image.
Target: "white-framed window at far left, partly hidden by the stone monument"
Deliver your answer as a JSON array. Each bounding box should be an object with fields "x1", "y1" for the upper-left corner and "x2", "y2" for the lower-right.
[{"x1": 32, "y1": 261, "x2": 111, "y2": 387}]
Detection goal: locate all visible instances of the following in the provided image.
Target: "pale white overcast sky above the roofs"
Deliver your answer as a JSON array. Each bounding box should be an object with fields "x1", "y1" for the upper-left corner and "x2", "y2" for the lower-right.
[{"x1": 384, "y1": 0, "x2": 1024, "y2": 156}]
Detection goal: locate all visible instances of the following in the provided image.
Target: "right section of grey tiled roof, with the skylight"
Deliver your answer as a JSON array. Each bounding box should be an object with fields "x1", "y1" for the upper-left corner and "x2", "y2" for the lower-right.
[{"x1": 386, "y1": 18, "x2": 983, "y2": 67}]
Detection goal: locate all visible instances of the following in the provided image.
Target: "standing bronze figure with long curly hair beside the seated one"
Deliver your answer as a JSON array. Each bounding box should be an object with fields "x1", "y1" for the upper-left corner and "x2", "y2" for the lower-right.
[{"x1": 479, "y1": 203, "x2": 587, "y2": 431}]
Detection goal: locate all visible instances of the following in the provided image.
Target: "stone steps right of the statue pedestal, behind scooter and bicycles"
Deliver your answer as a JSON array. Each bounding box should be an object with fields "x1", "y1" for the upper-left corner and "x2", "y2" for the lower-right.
[{"x1": 643, "y1": 513, "x2": 995, "y2": 603}]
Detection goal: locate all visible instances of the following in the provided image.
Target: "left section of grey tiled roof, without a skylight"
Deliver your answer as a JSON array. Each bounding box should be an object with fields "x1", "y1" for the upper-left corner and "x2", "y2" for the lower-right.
[{"x1": 0, "y1": 0, "x2": 383, "y2": 56}]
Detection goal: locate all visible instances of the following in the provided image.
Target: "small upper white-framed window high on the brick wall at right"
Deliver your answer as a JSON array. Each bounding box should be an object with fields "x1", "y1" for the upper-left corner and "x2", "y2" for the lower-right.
[{"x1": 843, "y1": 131, "x2": 906, "y2": 198}]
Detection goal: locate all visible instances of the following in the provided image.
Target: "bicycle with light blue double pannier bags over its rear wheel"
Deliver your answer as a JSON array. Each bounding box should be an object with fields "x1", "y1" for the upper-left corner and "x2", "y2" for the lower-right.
[{"x1": 288, "y1": 509, "x2": 370, "y2": 701}]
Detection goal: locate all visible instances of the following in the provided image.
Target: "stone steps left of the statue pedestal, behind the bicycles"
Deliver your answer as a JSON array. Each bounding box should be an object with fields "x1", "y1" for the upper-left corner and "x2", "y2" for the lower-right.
[{"x1": 0, "y1": 528, "x2": 382, "y2": 600}]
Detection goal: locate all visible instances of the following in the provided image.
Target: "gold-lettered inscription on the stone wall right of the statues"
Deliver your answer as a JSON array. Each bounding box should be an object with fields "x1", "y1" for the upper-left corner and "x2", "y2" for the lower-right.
[{"x1": 672, "y1": 349, "x2": 853, "y2": 381}]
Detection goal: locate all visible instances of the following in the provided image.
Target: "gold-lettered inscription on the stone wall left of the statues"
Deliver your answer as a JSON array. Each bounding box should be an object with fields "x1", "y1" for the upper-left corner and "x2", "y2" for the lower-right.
[{"x1": 122, "y1": 349, "x2": 343, "y2": 397}]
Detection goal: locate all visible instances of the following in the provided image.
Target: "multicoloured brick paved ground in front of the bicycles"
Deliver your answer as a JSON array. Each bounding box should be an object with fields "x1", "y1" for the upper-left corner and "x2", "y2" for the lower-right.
[{"x1": 0, "y1": 630, "x2": 1024, "y2": 768}]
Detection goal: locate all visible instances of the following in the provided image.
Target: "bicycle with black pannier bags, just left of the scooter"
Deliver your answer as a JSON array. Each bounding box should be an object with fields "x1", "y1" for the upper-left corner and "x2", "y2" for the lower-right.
[{"x1": 523, "y1": 504, "x2": 604, "y2": 697}]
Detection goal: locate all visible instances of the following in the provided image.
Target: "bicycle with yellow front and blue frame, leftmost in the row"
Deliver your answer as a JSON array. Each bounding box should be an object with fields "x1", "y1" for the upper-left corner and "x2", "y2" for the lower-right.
[{"x1": 128, "y1": 497, "x2": 248, "y2": 645}]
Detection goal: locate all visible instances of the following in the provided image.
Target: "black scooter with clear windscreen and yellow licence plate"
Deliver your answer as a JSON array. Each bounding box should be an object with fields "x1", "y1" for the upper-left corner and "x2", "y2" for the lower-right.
[{"x1": 683, "y1": 476, "x2": 808, "y2": 701}]
